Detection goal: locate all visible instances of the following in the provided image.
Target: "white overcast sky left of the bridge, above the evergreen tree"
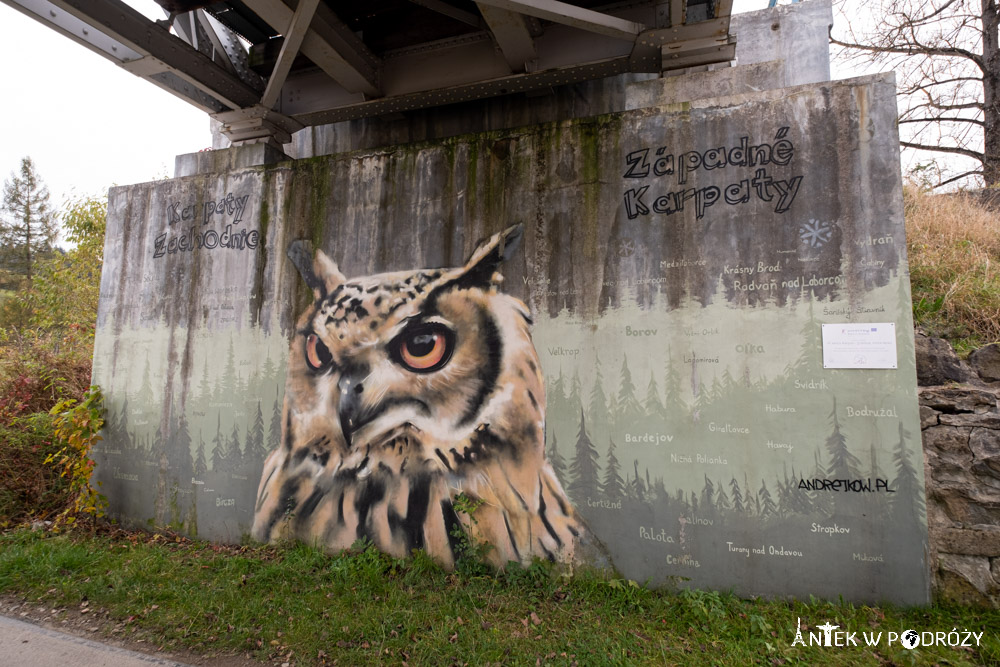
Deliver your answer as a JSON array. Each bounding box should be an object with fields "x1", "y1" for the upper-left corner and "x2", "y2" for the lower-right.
[{"x1": 0, "y1": 0, "x2": 816, "y2": 215}]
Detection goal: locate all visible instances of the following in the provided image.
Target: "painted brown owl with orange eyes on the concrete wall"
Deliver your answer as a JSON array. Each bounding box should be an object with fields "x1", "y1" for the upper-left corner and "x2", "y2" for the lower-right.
[{"x1": 253, "y1": 226, "x2": 592, "y2": 567}]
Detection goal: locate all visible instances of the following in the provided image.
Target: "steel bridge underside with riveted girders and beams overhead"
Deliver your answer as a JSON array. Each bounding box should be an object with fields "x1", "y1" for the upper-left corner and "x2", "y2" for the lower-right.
[{"x1": 0, "y1": 0, "x2": 736, "y2": 143}]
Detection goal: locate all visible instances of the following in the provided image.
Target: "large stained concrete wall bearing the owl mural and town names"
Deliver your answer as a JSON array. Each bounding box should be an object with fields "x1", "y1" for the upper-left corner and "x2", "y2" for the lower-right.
[{"x1": 95, "y1": 76, "x2": 929, "y2": 603}]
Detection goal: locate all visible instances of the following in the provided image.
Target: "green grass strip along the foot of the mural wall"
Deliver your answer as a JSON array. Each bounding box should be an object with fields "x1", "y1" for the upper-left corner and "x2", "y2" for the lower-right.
[{"x1": 0, "y1": 530, "x2": 1000, "y2": 665}]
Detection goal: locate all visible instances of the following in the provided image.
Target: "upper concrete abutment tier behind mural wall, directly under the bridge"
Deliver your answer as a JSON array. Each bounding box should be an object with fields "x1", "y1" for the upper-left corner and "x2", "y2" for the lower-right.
[{"x1": 199, "y1": 0, "x2": 833, "y2": 168}]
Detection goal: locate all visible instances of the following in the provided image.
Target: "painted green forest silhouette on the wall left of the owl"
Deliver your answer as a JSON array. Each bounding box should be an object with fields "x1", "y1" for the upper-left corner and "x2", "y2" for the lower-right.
[{"x1": 98, "y1": 340, "x2": 284, "y2": 539}]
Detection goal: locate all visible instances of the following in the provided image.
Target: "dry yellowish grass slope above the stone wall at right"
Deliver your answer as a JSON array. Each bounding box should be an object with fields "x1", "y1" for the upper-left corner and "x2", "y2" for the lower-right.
[{"x1": 904, "y1": 187, "x2": 1000, "y2": 352}]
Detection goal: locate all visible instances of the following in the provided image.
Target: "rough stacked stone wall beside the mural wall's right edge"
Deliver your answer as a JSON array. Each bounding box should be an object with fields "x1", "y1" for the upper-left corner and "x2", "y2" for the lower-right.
[{"x1": 916, "y1": 335, "x2": 1000, "y2": 607}]
